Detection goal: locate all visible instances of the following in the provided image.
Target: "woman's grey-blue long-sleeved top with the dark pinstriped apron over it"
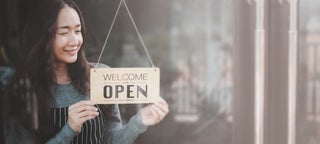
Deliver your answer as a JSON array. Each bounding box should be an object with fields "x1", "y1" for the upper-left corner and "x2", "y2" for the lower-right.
[{"x1": 47, "y1": 83, "x2": 147, "y2": 144}]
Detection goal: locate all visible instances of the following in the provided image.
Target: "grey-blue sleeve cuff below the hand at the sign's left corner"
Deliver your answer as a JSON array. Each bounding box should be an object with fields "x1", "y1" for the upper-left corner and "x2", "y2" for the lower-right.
[{"x1": 46, "y1": 123, "x2": 78, "y2": 144}]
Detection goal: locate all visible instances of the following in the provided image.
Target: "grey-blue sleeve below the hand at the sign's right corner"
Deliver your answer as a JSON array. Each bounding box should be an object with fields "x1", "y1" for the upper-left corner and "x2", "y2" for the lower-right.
[{"x1": 103, "y1": 105, "x2": 147, "y2": 144}]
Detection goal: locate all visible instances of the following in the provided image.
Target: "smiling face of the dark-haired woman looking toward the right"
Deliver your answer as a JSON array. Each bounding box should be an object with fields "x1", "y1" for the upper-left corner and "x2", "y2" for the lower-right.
[{"x1": 53, "y1": 6, "x2": 83, "y2": 64}]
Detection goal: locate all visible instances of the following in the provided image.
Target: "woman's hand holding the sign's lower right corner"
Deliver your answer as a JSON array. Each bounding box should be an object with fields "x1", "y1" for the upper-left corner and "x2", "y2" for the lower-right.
[{"x1": 140, "y1": 97, "x2": 169, "y2": 126}]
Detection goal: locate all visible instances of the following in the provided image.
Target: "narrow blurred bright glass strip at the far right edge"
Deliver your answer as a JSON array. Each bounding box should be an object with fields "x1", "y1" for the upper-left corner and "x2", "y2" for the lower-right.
[{"x1": 297, "y1": 0, "x2": 320, "y2": 144}]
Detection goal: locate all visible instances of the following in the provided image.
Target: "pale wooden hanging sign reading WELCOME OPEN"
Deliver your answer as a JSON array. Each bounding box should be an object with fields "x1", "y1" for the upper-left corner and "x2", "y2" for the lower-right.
[{"x1": 90, "y1": 68, "x2": 160, "y2": 104}]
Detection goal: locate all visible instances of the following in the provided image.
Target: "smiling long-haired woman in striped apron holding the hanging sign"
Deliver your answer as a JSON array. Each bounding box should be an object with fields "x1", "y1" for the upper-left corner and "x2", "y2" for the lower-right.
[{"x1": 5, "y1": 0, "x2": 169, "y2": 144}]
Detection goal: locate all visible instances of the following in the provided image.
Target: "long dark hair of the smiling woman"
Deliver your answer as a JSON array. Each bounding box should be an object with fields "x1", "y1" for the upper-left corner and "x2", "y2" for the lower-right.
[{"x1": 5, "y1": 0, "x2": 90, "y2": 141}]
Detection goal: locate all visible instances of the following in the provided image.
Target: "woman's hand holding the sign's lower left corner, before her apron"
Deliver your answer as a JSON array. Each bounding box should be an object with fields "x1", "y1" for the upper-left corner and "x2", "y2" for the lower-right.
[{"x1": 68, "y1": 101, "x2": 99, "y2": 133}]
